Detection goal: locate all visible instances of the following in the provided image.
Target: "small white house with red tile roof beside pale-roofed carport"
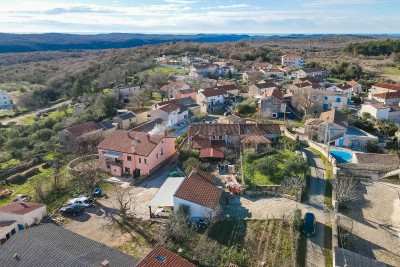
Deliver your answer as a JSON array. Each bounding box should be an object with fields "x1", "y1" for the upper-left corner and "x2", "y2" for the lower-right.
[{"x1": 174, "y1": 169, "x2": 222, "y2": 218}]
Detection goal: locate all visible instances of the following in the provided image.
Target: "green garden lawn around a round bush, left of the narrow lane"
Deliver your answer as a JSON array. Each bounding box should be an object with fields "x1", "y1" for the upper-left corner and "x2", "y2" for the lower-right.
[{"x1": 243, "y1": 150, "x2": 295, "y2": 185}]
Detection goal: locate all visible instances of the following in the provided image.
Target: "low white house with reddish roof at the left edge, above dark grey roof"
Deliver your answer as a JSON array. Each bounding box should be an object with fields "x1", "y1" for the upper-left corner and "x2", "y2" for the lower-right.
[{"x1": 0, "y1": 201, "x2": 46, "y2": 230}]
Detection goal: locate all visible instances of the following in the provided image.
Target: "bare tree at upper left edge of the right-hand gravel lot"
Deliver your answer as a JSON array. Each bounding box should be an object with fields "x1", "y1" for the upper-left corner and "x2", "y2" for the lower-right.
[{"x1": 332, "y1": 177, "x2": 359, "y2": 206}]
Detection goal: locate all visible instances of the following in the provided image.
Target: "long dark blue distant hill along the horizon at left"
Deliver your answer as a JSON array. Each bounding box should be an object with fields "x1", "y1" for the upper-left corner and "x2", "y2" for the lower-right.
[{"x1": 0, "y1": 33, "x2": 250, "y2": 53}]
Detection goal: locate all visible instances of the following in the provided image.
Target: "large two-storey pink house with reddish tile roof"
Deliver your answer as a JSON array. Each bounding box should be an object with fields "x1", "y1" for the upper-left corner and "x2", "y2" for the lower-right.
[{"x1": 97, "y1": 130, "x2": 176, "y2": 177}]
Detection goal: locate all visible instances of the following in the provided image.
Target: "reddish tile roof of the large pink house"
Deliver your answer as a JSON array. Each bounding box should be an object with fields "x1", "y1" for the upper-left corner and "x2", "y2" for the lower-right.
[{"x1": 97, "y1": 130, "x2": 175, "y2": 157}]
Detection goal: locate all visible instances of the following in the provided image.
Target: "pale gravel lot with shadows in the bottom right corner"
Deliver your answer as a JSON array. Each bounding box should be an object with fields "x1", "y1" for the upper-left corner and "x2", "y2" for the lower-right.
[{"x1": 341, "y1": 181, "x2": 400, "y2": 266}]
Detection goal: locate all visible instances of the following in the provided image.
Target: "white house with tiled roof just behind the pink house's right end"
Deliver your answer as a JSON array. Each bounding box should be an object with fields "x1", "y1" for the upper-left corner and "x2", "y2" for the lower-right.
[{"x1": 151, "y1": 103, "x2": 189, "y2": 125}]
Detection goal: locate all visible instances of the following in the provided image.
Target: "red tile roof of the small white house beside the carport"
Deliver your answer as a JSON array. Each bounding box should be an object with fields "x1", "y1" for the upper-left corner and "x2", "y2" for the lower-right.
[{"x1": 174, "y1": 170, "x2": 222, "y2": 208}]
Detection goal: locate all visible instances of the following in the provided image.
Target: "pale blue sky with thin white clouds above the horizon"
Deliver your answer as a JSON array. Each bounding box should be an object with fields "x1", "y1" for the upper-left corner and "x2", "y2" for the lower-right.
[{"x1": 0, "y1": 0, "x2": 400, "y2": 34}]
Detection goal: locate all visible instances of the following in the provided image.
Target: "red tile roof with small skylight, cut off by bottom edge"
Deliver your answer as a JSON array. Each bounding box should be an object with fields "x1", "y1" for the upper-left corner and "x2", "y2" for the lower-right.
[{"x1": 137, "y1": 245, "x2": 196, "y2": 267}]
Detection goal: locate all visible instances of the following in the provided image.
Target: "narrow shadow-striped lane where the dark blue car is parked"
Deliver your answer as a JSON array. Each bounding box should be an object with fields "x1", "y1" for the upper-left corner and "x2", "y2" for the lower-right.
[{"x1": 303, "y1": 149, "x2": 331, "y2": 267}]
